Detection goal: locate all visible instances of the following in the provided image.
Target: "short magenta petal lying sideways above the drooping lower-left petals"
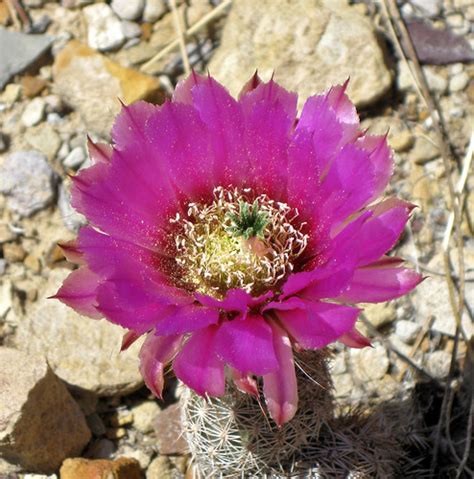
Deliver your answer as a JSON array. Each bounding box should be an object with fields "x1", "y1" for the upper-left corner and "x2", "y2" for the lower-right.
[{"x1": 155, "y1": 304, "x2": 219, "y2": 336}]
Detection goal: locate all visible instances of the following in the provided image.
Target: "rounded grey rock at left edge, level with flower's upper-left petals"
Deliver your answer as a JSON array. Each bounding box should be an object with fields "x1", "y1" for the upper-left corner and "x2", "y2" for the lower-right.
[{"x1": 0, "y1": 151, "x2": 56, "y2": 216}]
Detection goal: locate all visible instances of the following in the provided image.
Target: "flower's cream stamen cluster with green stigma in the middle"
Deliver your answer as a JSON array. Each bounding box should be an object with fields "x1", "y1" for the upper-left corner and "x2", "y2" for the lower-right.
[{"x1": 171, "y1": 187, "x2": 308, "y2": 298}]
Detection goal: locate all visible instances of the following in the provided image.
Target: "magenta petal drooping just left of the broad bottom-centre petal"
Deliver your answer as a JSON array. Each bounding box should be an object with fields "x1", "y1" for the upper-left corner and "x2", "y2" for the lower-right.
[{"x1": 173, "y1": 326, "x2": 225, "y2": 396}]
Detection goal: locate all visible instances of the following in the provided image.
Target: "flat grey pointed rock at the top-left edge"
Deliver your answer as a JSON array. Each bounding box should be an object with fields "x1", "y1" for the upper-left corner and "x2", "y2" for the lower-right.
[{"x1": 0, "y1": 28, "x2": 53, "y2": 90}]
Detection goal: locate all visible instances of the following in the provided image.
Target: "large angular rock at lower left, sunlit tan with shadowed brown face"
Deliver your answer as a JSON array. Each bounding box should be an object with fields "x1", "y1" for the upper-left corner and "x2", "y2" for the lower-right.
[{"x1": 0, "y1": 348, "x2": 91, "y2": 473}]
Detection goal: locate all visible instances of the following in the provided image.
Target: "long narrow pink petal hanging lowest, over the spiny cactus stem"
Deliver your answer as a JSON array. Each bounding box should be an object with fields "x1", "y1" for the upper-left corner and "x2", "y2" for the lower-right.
[{"x1": 263, "y1": 322, "x2": 298, "y2": 426}]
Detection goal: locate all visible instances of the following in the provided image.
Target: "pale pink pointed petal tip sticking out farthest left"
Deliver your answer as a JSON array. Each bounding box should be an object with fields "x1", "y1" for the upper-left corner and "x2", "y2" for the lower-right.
[{"x1": 52, "y1": 266, "x2": 102, "y2": 319}]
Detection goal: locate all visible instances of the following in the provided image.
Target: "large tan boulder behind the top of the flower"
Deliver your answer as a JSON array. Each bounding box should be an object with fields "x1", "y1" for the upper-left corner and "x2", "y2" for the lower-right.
[{"x1": 209, "y1": 0, "x2": 392, "y2": 107}]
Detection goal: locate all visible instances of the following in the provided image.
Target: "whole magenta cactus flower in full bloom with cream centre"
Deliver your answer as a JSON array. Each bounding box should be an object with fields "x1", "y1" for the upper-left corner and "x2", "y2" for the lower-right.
[{"x1": 56, "y1": 73, "x2": 421, "y2": 425}]
